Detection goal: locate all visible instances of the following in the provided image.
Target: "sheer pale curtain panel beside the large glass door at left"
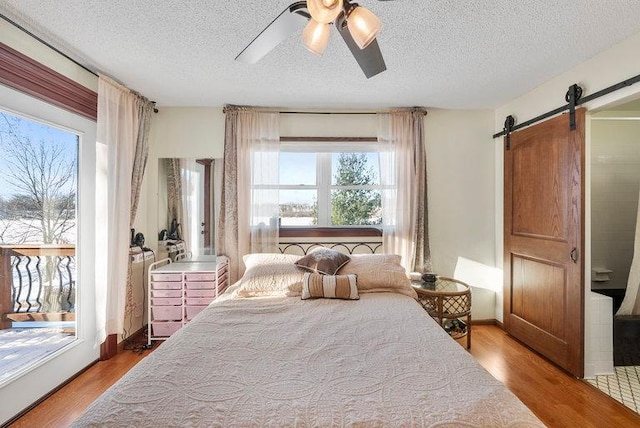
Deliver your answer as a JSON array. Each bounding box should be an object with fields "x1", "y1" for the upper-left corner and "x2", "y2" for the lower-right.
[{"x1": 96, "y1": 76, "x2": 140, "y2": 344}]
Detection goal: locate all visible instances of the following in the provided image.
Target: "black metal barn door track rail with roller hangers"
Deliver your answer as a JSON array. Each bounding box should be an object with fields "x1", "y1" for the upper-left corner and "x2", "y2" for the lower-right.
[{"x1": 493, "y1": 74, "x2": 640, "y2": 150}]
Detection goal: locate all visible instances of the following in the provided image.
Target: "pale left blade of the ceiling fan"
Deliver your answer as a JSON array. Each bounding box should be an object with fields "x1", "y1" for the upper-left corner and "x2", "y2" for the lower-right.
[{"x1": 236, "y1": 1, "x2": 311, "y2": 64}]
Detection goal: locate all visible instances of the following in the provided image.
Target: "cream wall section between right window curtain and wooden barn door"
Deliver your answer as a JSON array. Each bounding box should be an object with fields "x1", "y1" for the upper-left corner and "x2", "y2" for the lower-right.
[{"x1": 425, "y1": 109, "x2": 502, "y2": 320}]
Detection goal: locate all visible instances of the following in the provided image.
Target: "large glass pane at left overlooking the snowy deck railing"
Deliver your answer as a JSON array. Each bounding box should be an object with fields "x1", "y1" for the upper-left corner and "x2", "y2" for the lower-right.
[{"x1": 0, "y1": 111, "x2": 79, "y2": 382}]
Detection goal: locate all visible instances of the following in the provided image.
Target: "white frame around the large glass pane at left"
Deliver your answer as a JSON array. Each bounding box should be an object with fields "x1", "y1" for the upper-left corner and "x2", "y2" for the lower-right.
[{"x1": 0, "y1": 85, "x2": 100, "y2": 423}]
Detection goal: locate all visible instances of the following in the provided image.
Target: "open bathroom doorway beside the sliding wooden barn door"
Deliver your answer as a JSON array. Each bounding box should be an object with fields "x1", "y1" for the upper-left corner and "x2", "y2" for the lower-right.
[{"x1": 587, "y1": 96, "x2": 640, "y2": 412}]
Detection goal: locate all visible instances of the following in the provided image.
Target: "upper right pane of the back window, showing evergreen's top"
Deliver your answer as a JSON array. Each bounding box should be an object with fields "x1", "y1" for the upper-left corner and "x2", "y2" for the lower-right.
[{"x1": 331, "y1": 152, "x2": 380, "y2": 186}]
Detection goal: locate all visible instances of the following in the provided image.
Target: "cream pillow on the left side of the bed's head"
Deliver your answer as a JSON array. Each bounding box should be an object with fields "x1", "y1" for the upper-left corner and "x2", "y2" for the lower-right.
[{"x1": 236, "y1": 253, "x2": 304, "y2": 297}]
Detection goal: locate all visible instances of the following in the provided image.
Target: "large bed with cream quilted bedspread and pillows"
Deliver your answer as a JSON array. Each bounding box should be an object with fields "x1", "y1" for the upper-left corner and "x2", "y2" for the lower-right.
[{"x1": 74, "y1": 254, "x2": 543, "y2": 427}]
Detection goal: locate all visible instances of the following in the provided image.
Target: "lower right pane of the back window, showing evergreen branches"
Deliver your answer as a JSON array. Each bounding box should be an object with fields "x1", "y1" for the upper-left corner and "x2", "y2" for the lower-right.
[{"x1": 331, "y1": 189, "x2": 382, "y2": 226}]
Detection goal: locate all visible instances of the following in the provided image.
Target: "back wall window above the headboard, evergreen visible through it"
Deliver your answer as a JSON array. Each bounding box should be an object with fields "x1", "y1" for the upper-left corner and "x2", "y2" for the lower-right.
[{"x1": 278, "y1": 143, "x2": 383, "y2": 227}]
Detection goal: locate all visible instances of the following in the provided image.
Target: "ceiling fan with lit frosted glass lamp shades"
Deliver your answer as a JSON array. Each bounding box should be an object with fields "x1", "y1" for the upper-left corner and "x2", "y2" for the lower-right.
[{"x1": 236, "y1": 0, "x2": 390, "y2": 78}]
